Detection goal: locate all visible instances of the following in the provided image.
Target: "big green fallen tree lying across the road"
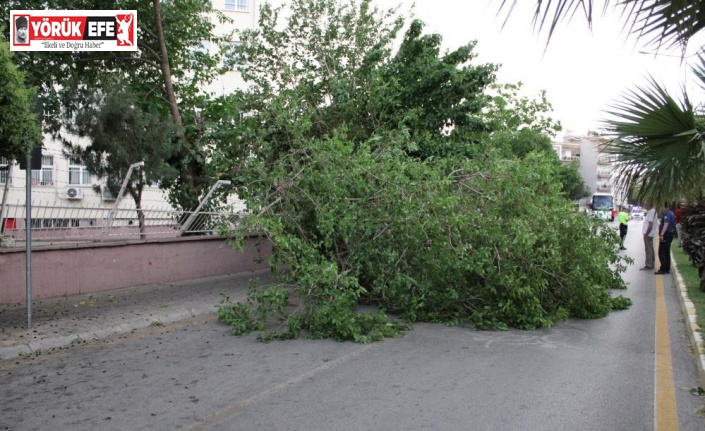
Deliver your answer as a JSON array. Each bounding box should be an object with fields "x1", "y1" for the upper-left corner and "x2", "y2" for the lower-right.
[{"x1": 220, "y1": 138, "x2": 629, "y2": 341}]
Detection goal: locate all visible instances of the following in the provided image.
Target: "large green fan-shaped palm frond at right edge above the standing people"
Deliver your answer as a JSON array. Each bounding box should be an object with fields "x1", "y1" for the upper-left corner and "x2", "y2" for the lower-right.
[{"x1": 603, "y1": 78, "x2": 705, "y2": 201}]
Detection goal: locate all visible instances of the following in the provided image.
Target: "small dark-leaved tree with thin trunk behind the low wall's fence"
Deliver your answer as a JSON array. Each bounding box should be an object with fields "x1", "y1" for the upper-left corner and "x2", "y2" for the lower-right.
[{"x1": 66, "y1": 85, "x2": 178, "y2": 236}]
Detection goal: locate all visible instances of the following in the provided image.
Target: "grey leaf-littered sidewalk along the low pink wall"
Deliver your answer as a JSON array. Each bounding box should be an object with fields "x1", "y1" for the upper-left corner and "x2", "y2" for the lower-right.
[{"x1": 0, "y1": 269, "x2": 270, "y2": 360}]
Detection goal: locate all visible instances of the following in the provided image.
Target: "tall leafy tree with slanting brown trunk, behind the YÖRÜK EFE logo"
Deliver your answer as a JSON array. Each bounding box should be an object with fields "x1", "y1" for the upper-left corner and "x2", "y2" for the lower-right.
[{"x1": 0, "y1": 0, "x2": 230, "y2": 209}]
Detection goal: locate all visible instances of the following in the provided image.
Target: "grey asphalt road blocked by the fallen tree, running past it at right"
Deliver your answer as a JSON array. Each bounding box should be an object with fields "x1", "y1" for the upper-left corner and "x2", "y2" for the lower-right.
[{"x1": 0, "y1": 222, "x2": 705, "y2": 431}]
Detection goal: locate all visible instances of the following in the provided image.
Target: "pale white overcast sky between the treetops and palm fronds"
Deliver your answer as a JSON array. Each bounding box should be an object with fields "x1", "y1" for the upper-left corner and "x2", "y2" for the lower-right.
[{"x1": 376, "y1": 0, "x2": 692, "y2": 135}]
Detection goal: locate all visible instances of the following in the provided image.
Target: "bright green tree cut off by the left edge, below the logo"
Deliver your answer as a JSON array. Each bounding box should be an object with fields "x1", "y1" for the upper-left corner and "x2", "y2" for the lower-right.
[{"x1": 0, "y1": 36, "x2": 42, "y2": 160}]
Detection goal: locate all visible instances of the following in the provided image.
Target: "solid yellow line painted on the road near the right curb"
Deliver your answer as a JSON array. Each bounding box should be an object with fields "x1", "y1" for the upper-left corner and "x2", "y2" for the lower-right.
[{"x1": 654, "y1": 275, "x2": 679, "y2": 431}]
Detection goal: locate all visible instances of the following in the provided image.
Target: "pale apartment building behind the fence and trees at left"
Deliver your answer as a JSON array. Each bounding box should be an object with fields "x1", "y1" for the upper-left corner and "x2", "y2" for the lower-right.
[{"x1": 0, "y1": 0, "x2": 257, "y2": 230}]
